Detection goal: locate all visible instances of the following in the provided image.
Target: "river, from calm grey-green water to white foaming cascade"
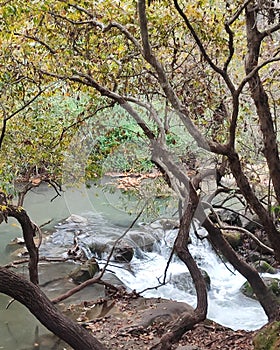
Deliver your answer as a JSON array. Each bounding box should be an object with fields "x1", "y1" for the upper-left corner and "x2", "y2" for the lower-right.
[{"x1": 0, "y1": 186, "x2": 274, "y2": 350}]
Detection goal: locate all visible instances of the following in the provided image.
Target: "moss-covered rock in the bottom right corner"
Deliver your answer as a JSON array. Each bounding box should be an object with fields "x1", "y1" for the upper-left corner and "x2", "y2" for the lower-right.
[{"x1": 253, "y1": 321, "x2": 280, "y2": 350}]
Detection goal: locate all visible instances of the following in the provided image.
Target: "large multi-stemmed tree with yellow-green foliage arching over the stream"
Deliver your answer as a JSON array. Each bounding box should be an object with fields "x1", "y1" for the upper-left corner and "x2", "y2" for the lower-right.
[{"x1": 0, "y1": 0, "x2": 280, "y2": 349}]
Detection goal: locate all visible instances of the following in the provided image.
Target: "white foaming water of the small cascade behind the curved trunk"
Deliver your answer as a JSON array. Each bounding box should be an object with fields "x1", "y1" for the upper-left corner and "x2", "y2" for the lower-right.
[{"x1": 104, "y1": 223, "x2": 267, "y2": 330}]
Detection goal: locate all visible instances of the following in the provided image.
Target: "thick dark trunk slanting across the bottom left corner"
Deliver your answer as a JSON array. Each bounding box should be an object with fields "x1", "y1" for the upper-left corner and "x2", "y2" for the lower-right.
[{"x1": 0, "y1": 267, "x2": 106, "y2": 350}]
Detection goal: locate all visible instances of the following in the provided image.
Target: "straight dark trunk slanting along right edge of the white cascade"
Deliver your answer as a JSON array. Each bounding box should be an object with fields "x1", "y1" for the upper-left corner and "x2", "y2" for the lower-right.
[{"x1": 202, "y1": 218, "x2": 280, "y2": 321}]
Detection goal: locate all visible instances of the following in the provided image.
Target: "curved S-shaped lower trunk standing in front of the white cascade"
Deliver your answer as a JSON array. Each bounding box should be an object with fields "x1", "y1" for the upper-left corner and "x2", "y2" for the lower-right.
[{"x1": 151, "y1": 185, "x2": 208, "y2": 350}]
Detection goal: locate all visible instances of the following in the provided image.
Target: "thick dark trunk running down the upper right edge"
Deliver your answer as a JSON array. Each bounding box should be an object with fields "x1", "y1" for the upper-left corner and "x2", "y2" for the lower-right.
[{"x1": 245, "y1": 4, "x2": 280, "y2": 204}]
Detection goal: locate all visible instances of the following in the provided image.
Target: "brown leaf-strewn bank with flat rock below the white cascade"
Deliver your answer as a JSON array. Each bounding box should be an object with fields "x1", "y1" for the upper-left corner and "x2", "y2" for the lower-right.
[{"x1": 50, "y1": 293, "x2": 255, "y2": 350}]
